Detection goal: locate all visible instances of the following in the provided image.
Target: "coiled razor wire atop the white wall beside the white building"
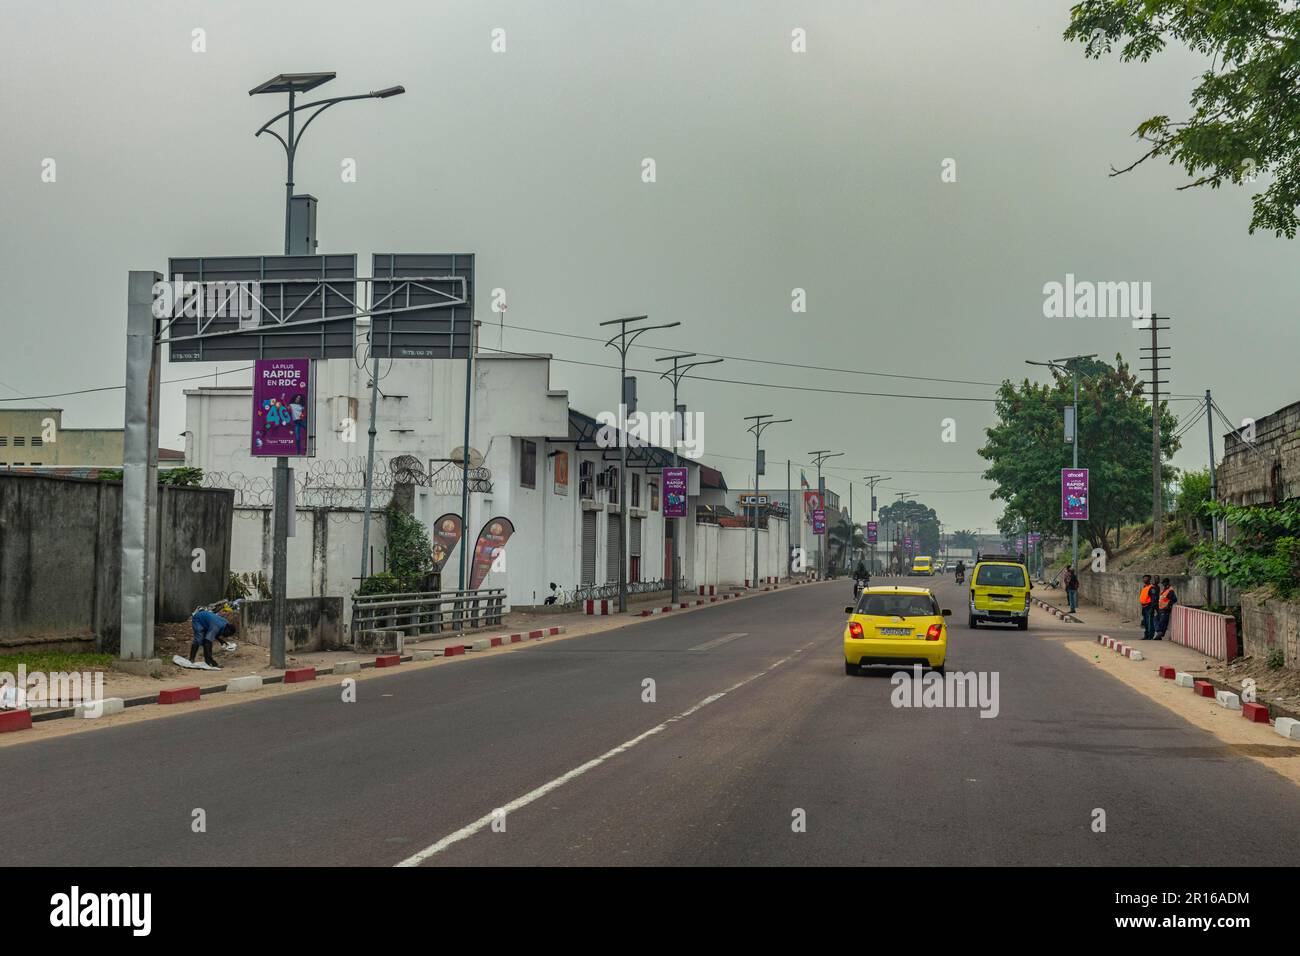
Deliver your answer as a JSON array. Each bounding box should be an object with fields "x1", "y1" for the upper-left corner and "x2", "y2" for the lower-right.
[{"x1": 203, "y1": 455, "x2": 491, "y2": 511}]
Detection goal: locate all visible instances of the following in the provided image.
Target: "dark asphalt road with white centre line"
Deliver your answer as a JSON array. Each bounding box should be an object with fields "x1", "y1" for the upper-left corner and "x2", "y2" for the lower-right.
[{"x1": 0, "y1": 578, "x2": 1300, "y2": 866}]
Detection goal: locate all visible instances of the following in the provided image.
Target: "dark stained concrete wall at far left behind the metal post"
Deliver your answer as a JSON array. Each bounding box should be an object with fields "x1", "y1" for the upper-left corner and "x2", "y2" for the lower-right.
[{"x1": 0, "y1": 472, "x2": 234, "y2": 652}]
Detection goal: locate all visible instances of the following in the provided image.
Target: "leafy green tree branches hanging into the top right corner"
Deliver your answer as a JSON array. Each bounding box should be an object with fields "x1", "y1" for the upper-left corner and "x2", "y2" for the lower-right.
[{"x1": 1065, "y1": 0, "x2": 1300, "y2": 239}]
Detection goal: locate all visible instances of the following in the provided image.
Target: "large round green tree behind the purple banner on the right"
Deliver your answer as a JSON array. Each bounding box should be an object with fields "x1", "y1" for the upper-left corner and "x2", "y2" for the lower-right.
[{"x1": 979, "y1": 355, "x2": 1179, "y2": 548}]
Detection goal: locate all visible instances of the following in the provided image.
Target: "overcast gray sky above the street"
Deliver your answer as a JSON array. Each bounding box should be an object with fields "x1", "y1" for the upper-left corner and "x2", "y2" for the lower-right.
[{"x1": 0, "y1": 0, "x2": 1300, "y2": 528}]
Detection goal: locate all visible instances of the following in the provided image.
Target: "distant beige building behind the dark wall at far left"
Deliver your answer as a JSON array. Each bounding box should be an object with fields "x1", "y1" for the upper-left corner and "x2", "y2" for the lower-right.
[{"x1": 0, "y1": 408, "x2": 185, "y2": 477}]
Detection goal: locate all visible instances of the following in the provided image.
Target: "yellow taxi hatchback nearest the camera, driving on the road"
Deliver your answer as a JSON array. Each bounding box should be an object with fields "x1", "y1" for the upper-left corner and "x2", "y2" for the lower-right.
[{"x1": 844, "y1": 585, "x2": 952, "y2": 674}]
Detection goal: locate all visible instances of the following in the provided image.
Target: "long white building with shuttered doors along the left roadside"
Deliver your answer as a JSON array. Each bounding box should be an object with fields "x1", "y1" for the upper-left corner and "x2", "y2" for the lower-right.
[{"x1": 186, "y1": 354, "x2": 789, "y2": 618}]
